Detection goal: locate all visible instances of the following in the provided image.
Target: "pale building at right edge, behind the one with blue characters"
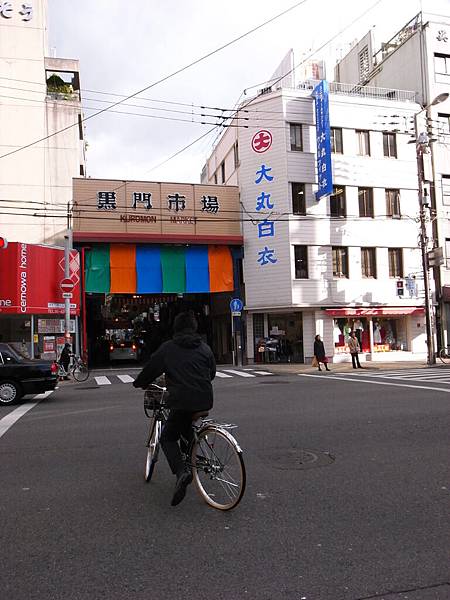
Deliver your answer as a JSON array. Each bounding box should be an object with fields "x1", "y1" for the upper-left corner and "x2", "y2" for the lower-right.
[{"x1": 336, "y1": 0, "x2": 450, "y2": 352}]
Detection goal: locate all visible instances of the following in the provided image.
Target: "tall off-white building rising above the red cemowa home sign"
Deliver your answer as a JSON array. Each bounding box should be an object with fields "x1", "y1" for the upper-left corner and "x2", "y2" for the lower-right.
[{"x1": 0, "y1": 0, "x2": 85, "y2": 243}]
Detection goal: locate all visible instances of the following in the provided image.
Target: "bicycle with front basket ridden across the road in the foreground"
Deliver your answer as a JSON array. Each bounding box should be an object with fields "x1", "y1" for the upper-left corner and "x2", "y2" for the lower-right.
[{"x1": 144, "y1": 383, "x2": 246, "y2": 511}]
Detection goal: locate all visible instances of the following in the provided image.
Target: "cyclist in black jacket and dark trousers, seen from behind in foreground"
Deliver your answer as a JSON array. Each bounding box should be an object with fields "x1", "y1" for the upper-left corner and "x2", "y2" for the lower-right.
[{"x1": 133, "y1": 312, "x2": 216, "y2": 506}]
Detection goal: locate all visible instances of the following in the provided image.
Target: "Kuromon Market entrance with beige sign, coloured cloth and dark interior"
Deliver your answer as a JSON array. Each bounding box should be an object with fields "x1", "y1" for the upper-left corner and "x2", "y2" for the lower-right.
[{"x1": 74, "y1": 179, "x2": 242, "y2": 364}]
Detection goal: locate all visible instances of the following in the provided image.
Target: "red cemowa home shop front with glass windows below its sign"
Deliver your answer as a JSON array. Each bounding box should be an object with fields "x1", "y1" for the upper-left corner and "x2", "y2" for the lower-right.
[{"x1": 0, "y1": 242, "x2": 80, "y2": 360}]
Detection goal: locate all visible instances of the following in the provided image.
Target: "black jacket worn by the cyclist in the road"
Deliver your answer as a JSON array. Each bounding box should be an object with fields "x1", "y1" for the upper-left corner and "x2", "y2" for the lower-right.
[{"x1": 133, "y1": 331, "x2": 216, "y2": 412}]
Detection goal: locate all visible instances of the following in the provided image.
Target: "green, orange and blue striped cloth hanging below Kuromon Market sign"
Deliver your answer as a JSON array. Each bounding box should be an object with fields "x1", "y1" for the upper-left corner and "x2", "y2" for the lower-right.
[{"x1": 85, "y1": 244, "x2": 234, "y2": 294}]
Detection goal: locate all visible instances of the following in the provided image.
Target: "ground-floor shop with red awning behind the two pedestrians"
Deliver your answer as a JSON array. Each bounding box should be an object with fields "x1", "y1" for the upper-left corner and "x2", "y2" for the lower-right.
[{"x1": 324, "y1": 306, "x2": 426, "y2": 362}]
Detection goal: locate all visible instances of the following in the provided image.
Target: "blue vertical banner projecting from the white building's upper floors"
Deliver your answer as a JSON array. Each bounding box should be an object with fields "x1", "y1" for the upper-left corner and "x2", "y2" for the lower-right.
[{"x1": 312, "y1": 81, "x2": 333, "y2": 200}]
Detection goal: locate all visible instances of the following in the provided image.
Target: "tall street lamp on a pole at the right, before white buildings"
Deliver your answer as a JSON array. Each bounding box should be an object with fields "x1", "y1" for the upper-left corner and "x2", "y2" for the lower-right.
[{"x1": 414, "y1": 92, "x2": 449, "y2": 365}]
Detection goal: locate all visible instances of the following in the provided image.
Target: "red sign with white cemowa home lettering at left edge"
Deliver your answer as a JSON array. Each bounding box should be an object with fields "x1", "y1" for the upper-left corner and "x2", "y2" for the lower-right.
[{"x1": 0, "y1": 242, "x2": 80, "y2": 315}]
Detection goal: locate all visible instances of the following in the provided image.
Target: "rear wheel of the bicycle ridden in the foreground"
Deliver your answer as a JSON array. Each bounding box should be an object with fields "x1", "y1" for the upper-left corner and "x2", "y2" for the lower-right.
[{"x1": 191, "y1": 426, "x2": 245, "y2": 510}]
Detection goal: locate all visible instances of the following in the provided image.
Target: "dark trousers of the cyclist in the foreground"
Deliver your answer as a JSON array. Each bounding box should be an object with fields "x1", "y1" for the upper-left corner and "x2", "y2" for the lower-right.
[{"x1": 161, "y1": 410, "x2": 193, "y2": 475}]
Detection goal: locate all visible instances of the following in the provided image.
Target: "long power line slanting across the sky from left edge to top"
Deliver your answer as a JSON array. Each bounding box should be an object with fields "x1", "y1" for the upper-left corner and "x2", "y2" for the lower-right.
[{"x1": 0, "y1": 0, "x2": 308, "y2": 158}]
